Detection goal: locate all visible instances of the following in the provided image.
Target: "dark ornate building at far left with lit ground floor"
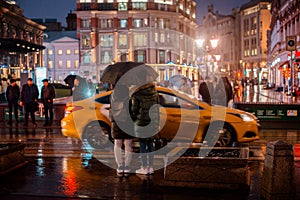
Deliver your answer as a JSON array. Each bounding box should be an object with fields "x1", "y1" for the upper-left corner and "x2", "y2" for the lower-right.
[{"x1": 0, "y1": 0, "x2": 46, "y2": 85}]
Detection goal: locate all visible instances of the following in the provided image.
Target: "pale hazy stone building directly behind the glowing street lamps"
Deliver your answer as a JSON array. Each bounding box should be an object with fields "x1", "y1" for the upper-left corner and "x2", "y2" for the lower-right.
[{"x1": 197, "y1": 5, "x2": 241, "y2": 78}]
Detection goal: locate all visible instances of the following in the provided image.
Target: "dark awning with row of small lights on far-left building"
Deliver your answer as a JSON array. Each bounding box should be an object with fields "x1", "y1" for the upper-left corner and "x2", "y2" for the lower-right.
[{"x1": 0, "y1": 38, "x2": 45, "y2": 53}]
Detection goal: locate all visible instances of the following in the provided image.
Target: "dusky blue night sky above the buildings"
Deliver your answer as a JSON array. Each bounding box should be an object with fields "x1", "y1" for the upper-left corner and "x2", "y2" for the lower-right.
[{"x1": 16, "y1": 0, "x2": 250, "y2": 26}]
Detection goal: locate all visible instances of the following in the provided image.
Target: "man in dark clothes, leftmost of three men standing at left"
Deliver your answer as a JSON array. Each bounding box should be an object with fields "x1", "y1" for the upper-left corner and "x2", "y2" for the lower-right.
[{"x1": 5, "y1": 79, "x2": 20, "y2": 126}]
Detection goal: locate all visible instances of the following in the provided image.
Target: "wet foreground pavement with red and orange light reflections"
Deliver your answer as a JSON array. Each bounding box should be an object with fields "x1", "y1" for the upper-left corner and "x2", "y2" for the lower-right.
[{"x1": 0, "y1": 154, "x2": 300, "y2": 200}]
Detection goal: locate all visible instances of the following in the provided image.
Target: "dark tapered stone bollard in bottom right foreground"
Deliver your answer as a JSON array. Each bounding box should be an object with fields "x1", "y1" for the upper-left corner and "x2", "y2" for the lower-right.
[{"x1": 261, "y1": 141, "x2": 296, "y2": 200}]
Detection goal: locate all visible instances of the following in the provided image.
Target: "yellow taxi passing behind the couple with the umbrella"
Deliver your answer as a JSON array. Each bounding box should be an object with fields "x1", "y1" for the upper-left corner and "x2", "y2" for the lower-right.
[{"x1": 61, "y1": 87, "x2": 260, "y2": 148}]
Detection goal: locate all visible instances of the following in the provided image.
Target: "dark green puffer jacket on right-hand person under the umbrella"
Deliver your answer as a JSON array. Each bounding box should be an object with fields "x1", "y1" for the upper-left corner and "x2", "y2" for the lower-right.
[{"x1": 131, "y1": 83, "x2": 159, "y2": 137}]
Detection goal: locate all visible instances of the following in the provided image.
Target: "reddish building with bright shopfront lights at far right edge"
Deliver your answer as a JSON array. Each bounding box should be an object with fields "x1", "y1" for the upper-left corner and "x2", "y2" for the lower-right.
[{"x1": 268, "y1": 0, "x2": 300, "y2": 86}]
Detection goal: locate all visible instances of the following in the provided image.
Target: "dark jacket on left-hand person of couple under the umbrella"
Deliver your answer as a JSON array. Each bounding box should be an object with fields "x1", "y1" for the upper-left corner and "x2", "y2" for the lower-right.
[{"x1": 109, "y1": 86, "x2": 134, "y2": 139}]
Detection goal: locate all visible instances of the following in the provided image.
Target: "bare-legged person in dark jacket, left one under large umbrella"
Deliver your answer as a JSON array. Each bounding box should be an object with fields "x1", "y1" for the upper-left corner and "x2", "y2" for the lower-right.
[{"x1": 109, "y1": 85, "x2": 134, "y2": 175}]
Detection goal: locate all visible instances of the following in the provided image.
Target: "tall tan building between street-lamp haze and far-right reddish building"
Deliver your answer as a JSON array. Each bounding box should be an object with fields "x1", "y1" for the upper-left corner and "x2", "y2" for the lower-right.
[{"x1": 240, "y1": 0, "x2": 271, "y2": 83}]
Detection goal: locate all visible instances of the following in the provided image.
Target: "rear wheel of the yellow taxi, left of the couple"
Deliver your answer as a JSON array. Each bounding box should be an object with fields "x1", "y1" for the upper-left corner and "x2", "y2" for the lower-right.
[{"x1": 82, "y1": 121, "x2": 112, "y2": 149}]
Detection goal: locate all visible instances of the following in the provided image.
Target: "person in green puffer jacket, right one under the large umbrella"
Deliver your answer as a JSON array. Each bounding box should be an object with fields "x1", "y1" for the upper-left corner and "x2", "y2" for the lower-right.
[{"x1": 131, "y1": 79, "x2": 159, "y2": 175}]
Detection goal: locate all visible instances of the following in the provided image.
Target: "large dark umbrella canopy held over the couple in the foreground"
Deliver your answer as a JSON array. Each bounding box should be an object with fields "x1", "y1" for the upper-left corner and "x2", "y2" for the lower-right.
[{"x1": 100, "y1": 62, "x2": 158, "y2": 85}]
